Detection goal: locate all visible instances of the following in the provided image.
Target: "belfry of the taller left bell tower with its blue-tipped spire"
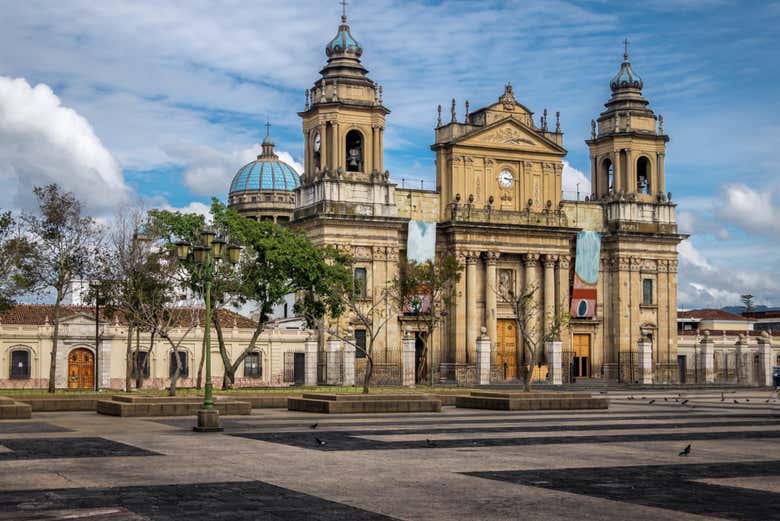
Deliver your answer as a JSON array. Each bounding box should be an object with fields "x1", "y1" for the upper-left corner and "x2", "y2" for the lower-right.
[{"x1": 299, "y1": 8, "x2": 390, "y2": 185}]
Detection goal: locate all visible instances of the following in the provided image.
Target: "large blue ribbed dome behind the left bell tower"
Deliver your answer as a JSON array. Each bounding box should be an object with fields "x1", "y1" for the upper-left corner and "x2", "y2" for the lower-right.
[{"x1": 230, "y1": 129, "x2": 301, "y2": 194}]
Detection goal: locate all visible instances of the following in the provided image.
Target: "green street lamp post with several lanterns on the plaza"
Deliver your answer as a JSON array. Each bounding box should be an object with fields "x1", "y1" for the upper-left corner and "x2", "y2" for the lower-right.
[{"x1": 176, "y1": 229, "x2": 241, "y2": 432}]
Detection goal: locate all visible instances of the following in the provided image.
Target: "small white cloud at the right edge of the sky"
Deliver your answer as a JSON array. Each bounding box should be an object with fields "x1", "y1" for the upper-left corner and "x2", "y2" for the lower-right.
[{"x1": 718, "y1": 184, "x2": 780, "y2": 236}]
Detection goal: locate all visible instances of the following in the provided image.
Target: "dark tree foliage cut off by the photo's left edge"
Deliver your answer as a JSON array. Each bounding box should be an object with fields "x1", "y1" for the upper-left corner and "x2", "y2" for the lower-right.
[{"x1": 0, "y1": 212, "x2": 36, "y2": 310}]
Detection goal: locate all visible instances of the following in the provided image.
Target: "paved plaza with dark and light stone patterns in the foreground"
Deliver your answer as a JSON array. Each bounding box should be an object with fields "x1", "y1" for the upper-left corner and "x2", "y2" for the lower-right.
[{"x1": 0, "y1": 389, "x2": 780, "y2": 521}]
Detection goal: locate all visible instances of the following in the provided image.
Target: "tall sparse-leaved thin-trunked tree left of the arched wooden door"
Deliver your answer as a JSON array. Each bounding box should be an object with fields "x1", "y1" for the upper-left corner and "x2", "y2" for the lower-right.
[{"x1": 22, "y1": 184, "x2": 102, "y2": 393}]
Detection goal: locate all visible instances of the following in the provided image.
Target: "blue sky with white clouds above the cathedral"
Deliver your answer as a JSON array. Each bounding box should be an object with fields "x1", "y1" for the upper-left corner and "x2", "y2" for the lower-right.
[{"x1": 0, "y1": 0, "x2": 780, "y2": 307}]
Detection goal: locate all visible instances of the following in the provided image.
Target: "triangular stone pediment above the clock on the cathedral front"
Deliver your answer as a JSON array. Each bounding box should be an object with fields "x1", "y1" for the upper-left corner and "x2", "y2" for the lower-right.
[{"x1": 453, "y1": 117, "x2": 566, "y2": 155}]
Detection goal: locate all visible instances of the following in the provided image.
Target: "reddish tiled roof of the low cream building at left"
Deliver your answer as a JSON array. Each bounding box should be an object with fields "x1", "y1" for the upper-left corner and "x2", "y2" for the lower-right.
[{"x1": 0, "y1": 304, "x2": 257, "y2": 329}]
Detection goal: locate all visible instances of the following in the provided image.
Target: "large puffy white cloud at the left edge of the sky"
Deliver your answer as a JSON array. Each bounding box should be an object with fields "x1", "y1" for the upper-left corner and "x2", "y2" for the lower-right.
[{"x1": 0, "y1": 76, "x2": 131, "y2": 212}]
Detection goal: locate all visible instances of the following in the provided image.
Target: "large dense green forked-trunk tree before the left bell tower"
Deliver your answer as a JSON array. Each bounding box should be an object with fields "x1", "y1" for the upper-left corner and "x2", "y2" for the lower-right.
[{"x1": 152, "y1": 199, "x2": 350, "y2": 387}]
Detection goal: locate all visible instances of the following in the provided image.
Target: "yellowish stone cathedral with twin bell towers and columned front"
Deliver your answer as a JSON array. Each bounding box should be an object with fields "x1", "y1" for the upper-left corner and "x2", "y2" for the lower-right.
[{"x1": 229, "y1": 16, "x2": 684, "y2": 383}]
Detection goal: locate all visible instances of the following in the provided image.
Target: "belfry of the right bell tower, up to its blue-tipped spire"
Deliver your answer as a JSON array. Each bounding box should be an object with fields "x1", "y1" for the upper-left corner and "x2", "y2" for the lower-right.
[{"x1": 586, "y1": 40, "x2": 669, "y2": 202}]
